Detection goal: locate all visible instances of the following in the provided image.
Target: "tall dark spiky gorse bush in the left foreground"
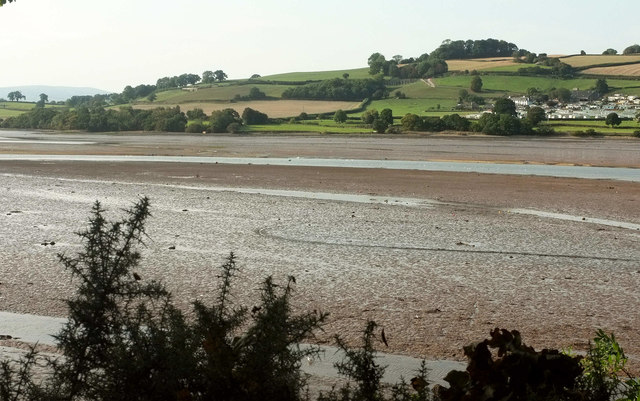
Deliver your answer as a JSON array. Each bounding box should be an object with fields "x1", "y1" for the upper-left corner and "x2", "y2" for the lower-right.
[{"x1": 0, "y1": 198, "x2": 327, "y2": 401}]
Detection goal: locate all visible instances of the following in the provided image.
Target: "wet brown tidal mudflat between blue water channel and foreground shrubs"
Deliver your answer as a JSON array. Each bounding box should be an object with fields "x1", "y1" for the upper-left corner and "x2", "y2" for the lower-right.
[{"x1": 0, "y1": 135, "x2": 640, "y2": 366}]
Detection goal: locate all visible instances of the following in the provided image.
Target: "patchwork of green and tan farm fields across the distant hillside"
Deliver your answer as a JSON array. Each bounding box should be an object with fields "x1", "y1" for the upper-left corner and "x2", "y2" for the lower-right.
[{"x1": 5, "y1": 55, "x2": 640, "y2": 132}]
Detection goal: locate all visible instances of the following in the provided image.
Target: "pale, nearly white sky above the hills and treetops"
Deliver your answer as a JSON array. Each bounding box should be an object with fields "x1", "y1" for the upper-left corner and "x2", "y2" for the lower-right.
[{"x1": 0, "y1": 0, "x2": 640, "y2": 92}]
